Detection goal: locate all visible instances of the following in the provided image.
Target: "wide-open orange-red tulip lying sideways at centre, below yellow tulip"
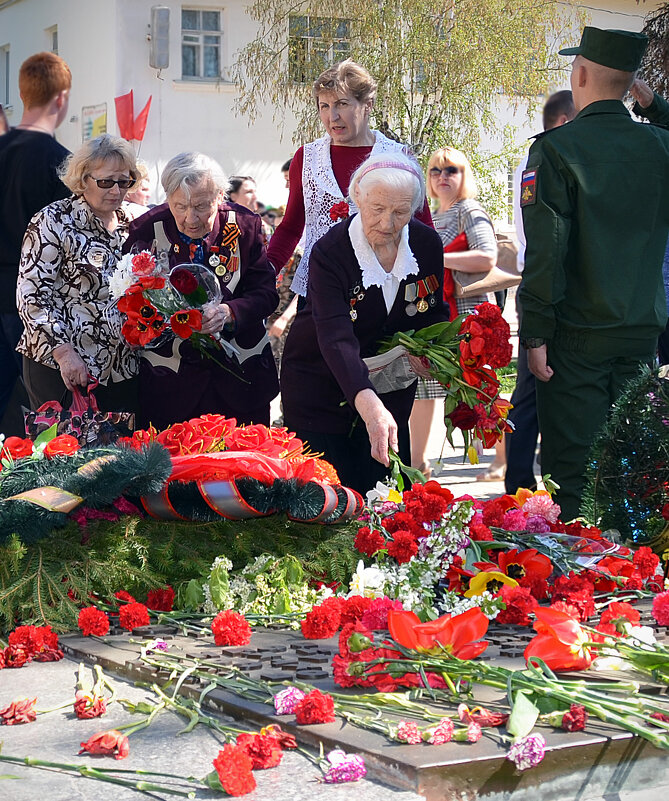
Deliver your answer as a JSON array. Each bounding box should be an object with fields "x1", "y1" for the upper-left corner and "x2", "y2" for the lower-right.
[{"x1": 388, "y1": 606, "x2": 488, "y2": 659}]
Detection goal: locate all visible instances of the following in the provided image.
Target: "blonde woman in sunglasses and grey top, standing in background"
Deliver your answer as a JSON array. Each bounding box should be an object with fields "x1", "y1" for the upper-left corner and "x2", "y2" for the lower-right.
[{"x1": 411, "y1": 147, "x2": 497, "y2": 478}]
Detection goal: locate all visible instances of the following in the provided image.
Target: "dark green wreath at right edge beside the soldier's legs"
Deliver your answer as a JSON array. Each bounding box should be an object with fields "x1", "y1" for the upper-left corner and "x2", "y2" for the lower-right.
[{"x1": 581, "y1": 368, "x2": 669, "y2": 545}]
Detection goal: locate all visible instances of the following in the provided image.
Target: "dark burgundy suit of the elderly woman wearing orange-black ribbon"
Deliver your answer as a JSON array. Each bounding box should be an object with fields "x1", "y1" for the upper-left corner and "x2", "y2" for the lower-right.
[{"x1": 123, "y1": 203, "x2": 279, "y2": 422}]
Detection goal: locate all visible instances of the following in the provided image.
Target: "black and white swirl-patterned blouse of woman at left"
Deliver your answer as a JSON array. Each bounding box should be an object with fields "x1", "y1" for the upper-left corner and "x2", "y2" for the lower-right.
[{"x1": 16, "y1": 197, "x2": 139, "y2": 384}]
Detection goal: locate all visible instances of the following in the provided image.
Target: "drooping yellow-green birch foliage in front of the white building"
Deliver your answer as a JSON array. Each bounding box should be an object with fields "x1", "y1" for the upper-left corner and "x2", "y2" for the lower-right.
[{"x1": 233, "y1": 0, "x2": 582, "y2": 154}]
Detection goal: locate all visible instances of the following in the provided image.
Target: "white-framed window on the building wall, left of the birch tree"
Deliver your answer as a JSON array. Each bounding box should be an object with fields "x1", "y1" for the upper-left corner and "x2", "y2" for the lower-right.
[{"x1": 181, "y1": 8, "x2": 223, "y2": 80}]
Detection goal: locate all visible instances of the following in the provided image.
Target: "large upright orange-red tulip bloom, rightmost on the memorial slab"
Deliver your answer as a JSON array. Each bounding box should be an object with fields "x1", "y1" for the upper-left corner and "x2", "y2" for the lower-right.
[{"x1": 524, "y1": 607, "x2": 593, "y2": 671}]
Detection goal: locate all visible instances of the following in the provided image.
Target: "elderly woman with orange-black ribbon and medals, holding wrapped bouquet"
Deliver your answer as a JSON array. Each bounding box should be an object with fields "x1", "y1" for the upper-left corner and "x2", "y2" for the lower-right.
[{"x1": 124, "y1": 153, "x2": 278, "y2": 428}]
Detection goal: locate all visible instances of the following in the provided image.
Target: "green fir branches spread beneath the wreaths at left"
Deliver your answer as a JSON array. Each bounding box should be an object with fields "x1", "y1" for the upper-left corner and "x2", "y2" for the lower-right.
[{"x1": 0, "y1": 515, "x2": 358, "y2": 631}]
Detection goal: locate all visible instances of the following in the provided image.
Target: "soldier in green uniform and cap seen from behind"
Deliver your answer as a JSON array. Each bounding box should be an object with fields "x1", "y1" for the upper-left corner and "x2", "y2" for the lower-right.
[{"x1": 520, "y1": 27, "x2": 669, "y2": 520}]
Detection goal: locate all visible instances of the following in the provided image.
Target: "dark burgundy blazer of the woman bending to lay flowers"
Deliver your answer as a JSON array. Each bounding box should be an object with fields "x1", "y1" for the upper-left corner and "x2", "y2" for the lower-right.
[{"x1": 281, "y1": 219, "x2": 448, "y2": 434}]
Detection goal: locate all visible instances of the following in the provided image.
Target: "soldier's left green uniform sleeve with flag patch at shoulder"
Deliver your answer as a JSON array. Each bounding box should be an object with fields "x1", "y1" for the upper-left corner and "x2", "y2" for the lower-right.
[{"x1": 519, "y1": 136, "x2": 575, "y2": 339}]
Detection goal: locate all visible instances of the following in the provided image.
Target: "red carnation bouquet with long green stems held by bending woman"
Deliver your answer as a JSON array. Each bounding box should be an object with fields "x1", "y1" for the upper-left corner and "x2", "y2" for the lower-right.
[{"x1": 382, "y1": 303, "x2": 512, "y2": 463}]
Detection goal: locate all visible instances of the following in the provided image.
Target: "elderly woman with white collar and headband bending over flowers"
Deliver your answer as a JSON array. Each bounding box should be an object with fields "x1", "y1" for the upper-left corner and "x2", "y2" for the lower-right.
[{"x1": 281, "y1": 153, "x2": 447, "y2": 492}]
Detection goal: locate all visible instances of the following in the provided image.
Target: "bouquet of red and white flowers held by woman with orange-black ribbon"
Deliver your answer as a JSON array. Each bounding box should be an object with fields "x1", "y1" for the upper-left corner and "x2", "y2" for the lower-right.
[{"x1": 109, "y1": 250, "x2": 222, "y2": 350}]
